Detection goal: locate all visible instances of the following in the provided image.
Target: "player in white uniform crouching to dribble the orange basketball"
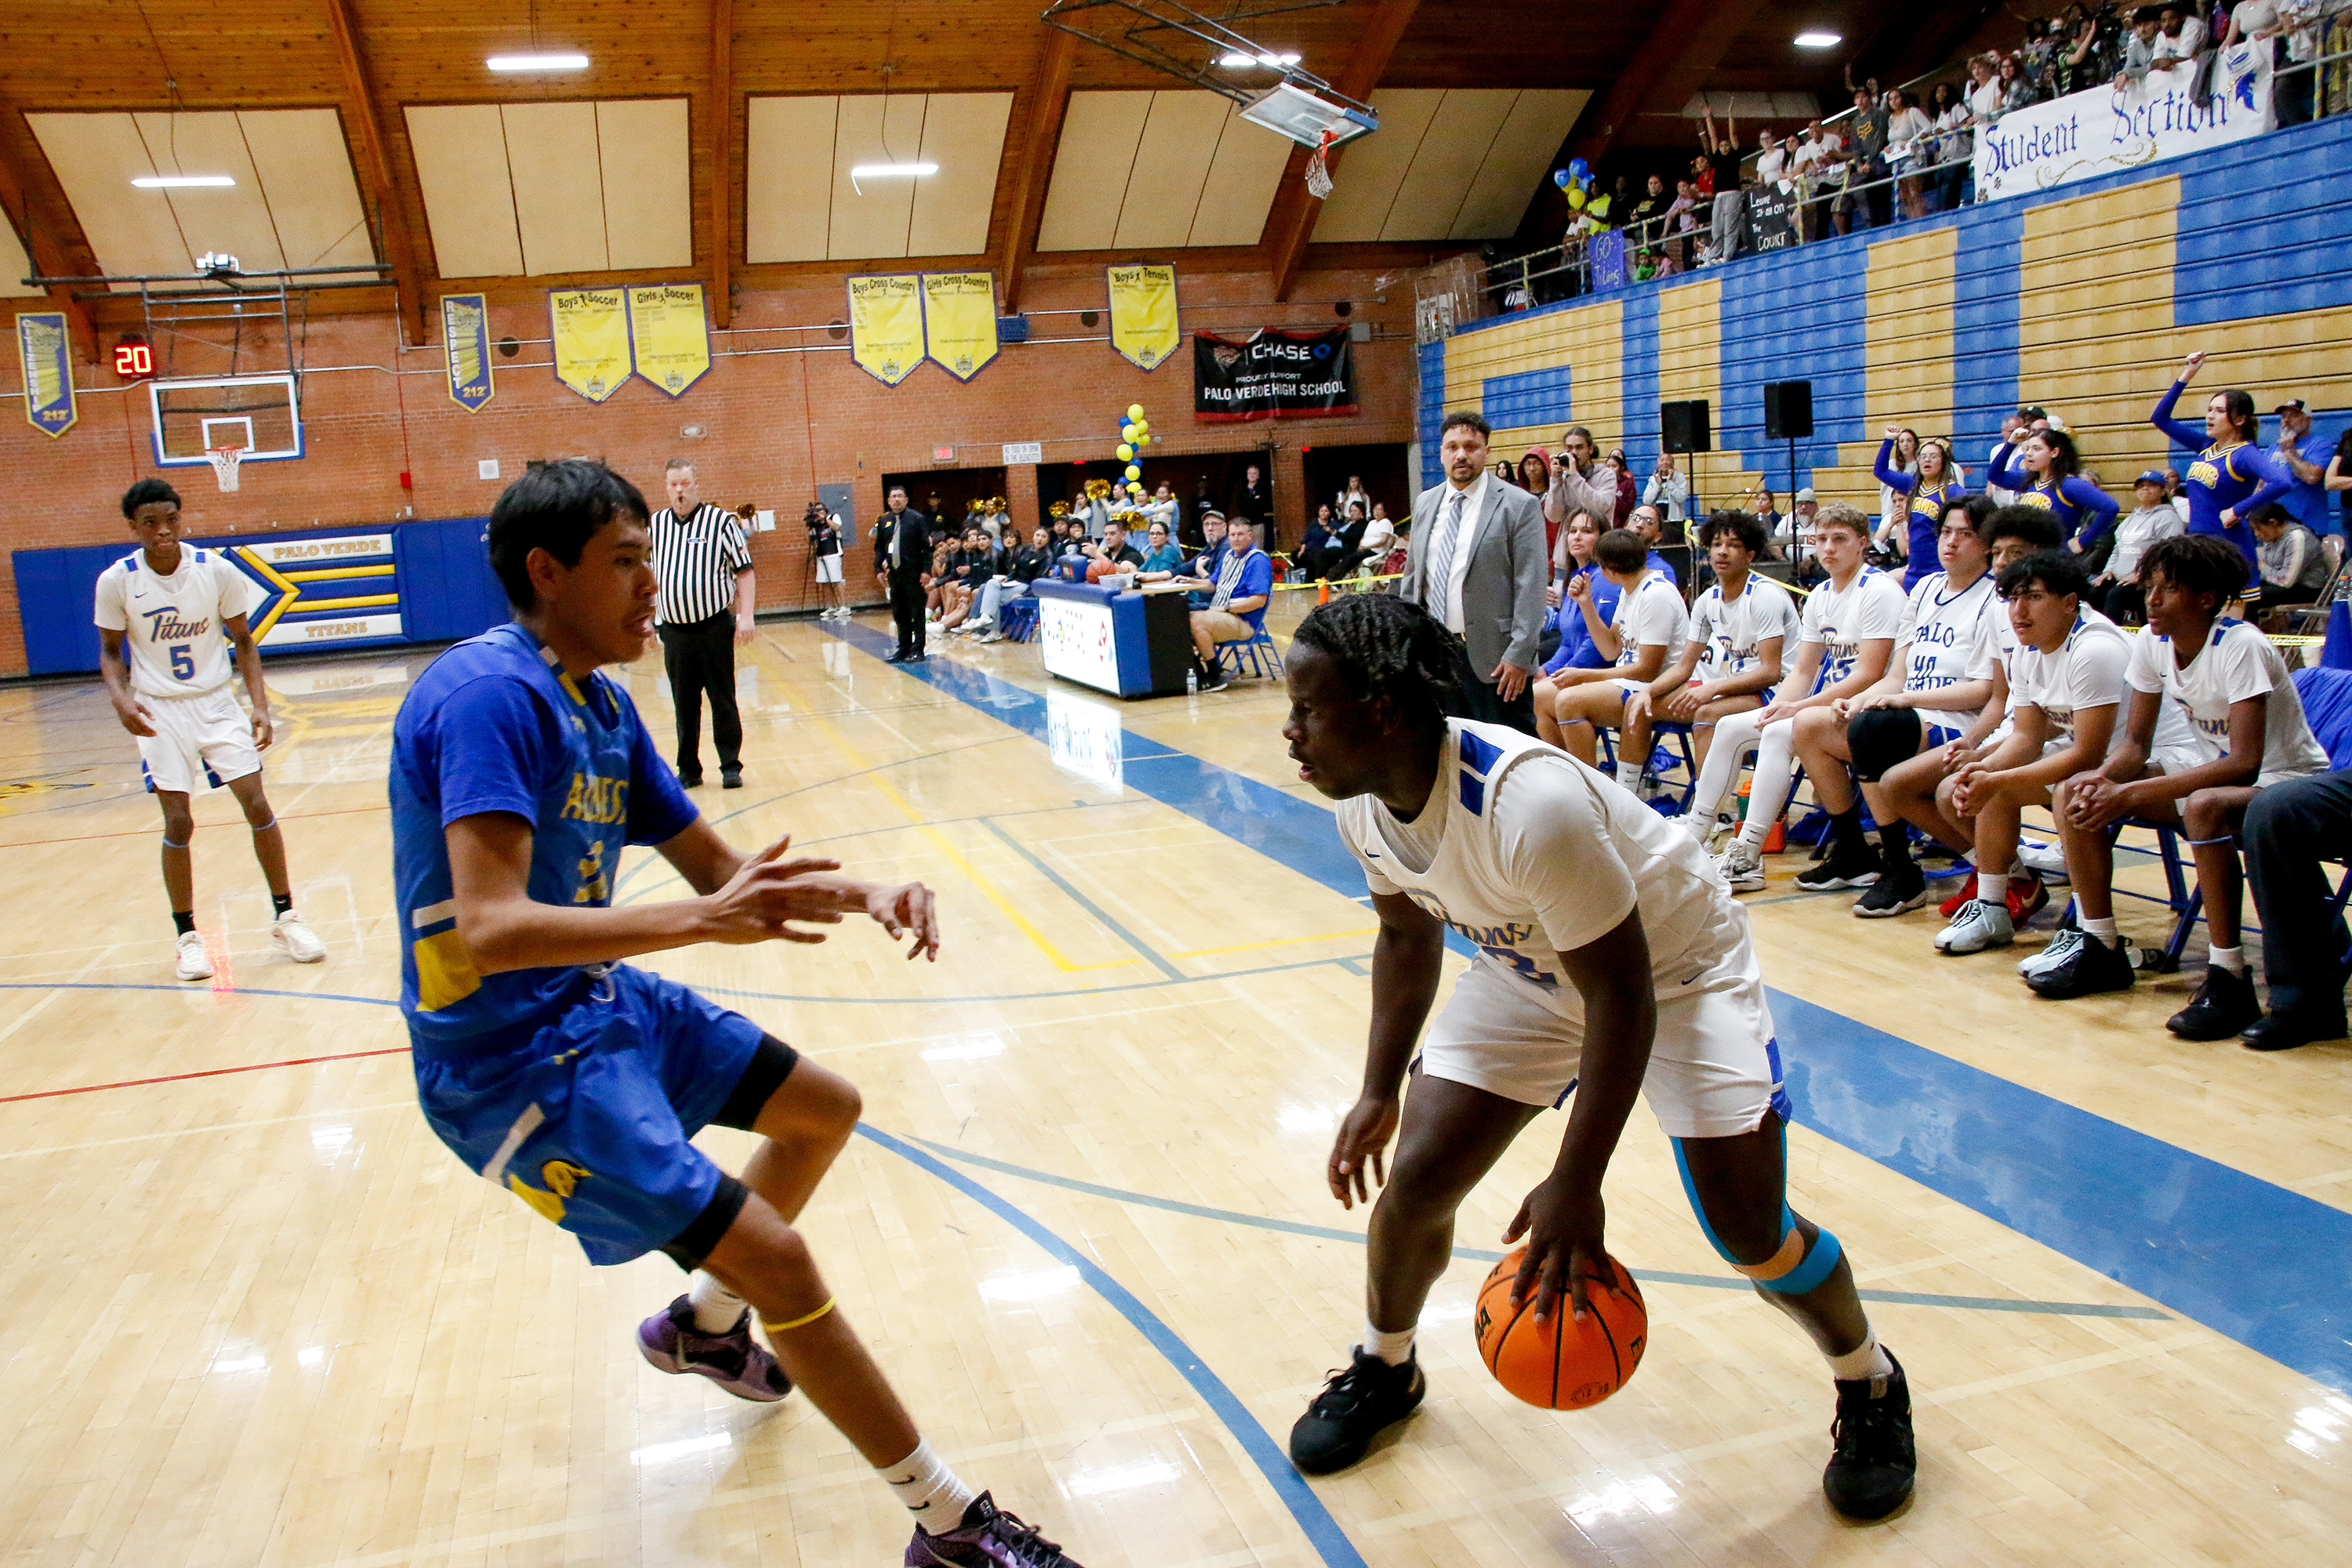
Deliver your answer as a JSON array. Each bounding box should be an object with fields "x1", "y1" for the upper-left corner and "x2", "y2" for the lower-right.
[{"x1": 1282, "y1": 595, "x2": 1917, "y2": 1519}]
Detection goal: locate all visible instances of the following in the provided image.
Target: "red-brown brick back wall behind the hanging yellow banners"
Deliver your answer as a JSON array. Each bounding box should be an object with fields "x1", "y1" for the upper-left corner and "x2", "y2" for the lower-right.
[{"x1": 0, "y1": 266, "x2": 1414, "y2": 675}]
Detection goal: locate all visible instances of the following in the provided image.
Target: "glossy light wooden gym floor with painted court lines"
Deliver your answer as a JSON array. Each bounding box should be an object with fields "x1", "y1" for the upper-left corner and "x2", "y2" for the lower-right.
[{"x1": 0, "y1": 616, "x2": 2352, "y2": 1568}]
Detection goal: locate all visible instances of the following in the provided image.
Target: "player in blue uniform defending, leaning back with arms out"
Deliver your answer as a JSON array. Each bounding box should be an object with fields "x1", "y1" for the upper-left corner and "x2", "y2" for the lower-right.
[{"x1": 390, "y1": 461, "x2": 1068, "y2": 1568}]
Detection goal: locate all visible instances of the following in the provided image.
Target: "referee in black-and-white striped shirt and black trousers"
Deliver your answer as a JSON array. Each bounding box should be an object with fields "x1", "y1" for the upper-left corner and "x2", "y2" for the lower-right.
[{"x1": 652, "y1": 459, "x2": 760, "y2": 789}]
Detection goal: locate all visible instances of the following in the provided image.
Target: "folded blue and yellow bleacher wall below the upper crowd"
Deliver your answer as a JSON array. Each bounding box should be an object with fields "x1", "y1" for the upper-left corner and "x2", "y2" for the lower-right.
[{"x1": 1421, "y1": 118, "x2": 2352, "y2": 521}]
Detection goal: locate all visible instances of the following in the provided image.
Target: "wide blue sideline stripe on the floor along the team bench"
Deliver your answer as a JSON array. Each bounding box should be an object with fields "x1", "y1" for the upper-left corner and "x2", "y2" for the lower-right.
[{"x1": 833, "y1": 623, "x2": 2352, "y2": 1394}]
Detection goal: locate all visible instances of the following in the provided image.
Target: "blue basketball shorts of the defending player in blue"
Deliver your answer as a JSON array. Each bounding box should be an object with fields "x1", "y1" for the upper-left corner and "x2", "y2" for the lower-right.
[{"x1": 416, "y1": 964, "x2": 800, "y2": 1269}]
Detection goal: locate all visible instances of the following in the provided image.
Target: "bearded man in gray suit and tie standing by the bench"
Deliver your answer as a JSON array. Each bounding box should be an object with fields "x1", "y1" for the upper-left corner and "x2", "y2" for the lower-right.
[{"x1": 1399, "y1": 414, "x2": 1548, "y2": 734}]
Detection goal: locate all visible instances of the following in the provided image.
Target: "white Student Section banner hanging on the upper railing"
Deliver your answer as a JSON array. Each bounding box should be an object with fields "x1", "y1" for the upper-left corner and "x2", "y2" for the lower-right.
[{"x1": 1976, "y1": 42, "x2": 2272, "y2": 202}]
